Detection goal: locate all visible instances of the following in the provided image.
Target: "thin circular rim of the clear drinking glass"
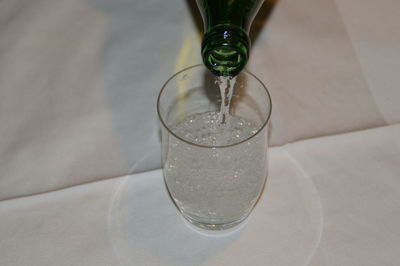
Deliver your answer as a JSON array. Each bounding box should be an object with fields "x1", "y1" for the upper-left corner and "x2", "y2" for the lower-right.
[{"x1": 157, "y1": 64, "x2": 272, "y2": 149}]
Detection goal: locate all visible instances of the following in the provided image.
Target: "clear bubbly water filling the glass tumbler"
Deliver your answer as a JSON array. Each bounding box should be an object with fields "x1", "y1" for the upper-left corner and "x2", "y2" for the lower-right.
[{"x1": 164, "y1": 111, "x2": 267, "y2": 227}]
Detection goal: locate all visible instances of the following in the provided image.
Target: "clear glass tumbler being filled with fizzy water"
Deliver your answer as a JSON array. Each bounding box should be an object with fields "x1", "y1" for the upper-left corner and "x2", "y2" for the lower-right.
[{"x1": 157, "y1": 65, "x2": 271, "y2": 230}]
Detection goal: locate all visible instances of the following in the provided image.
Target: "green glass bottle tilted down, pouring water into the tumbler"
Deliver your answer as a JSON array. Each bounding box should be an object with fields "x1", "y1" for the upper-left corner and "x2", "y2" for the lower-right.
[{"x1": 196, "y1": 0, "x2": 263, "y2": 76}]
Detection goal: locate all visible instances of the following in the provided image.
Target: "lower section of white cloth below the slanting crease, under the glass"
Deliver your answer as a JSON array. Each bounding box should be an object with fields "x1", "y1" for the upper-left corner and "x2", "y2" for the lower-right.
[{"x1": 0, "y1": 125, "x2": 400, "y2": 266}]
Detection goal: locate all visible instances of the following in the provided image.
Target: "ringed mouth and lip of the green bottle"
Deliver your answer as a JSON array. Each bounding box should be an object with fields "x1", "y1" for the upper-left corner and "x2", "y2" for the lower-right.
[{"x1": 202, "y1": 25, "x2": 250, "y2": 76}]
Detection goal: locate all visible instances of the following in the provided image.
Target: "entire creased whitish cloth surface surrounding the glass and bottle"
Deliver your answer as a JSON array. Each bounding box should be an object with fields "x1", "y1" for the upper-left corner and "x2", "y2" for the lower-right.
[{"x1": 0, "y1": 0, "x2": 400, "y2": 266}]
